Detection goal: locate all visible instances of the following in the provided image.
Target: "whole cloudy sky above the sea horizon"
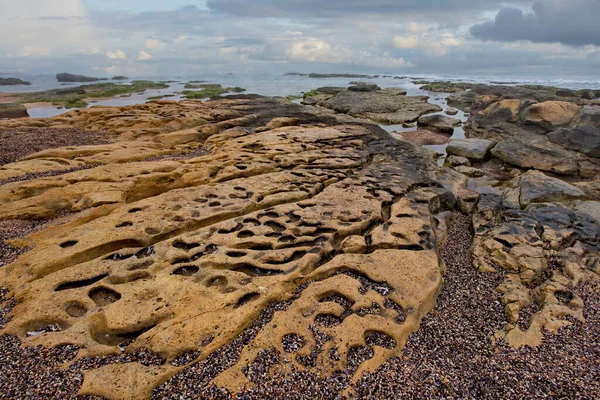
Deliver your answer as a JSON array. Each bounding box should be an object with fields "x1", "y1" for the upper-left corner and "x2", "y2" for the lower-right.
[{"x1": 0, "y1": 0, "x2": 600, "y2": 78}]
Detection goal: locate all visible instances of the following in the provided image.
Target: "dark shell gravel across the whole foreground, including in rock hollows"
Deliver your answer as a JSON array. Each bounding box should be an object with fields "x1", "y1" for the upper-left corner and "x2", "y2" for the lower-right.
[{"x1": 0, "y1": 215, "x2": 600, "y2": 399}]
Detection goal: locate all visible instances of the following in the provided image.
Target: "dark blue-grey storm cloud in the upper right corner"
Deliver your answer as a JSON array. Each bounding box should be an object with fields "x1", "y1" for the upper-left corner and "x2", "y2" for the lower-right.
[{"x1": 471, "y1": 0, "x2": 600, "y2": 46}]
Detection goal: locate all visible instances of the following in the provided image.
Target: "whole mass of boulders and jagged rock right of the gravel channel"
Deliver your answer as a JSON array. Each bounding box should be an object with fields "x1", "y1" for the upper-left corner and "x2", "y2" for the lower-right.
[{"x1": 440, "y1": 85, "x2": 600, "y2": 347}]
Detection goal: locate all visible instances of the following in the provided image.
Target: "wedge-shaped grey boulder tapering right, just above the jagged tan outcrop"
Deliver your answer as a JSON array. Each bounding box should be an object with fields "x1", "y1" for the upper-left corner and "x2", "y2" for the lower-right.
[{"x1": 517, "y1": 171, "x2": 585, "y2": 207}]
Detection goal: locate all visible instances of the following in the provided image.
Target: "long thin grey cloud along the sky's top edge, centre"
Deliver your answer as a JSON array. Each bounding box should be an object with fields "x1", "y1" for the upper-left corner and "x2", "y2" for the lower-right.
[{"x1": 207, "y1": 0, "x2": 524, "y2": 17}]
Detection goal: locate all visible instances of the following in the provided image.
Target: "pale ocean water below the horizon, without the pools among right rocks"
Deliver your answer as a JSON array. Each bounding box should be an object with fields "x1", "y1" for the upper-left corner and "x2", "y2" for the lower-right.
[{"x1": 0, "y1": 74, "x2": 600, "y2": 119}]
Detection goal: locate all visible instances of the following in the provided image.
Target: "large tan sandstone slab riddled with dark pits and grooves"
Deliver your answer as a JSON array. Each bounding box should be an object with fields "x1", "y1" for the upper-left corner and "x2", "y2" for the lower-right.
[{"x1": 0, "y1": 92, "x2": 454, "y2": 398}]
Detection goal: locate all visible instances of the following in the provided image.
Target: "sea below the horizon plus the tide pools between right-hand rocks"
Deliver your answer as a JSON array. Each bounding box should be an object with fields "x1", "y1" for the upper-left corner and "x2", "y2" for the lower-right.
[{"x1": 0, "y1": 73, "x2": 600, "y2": 198}]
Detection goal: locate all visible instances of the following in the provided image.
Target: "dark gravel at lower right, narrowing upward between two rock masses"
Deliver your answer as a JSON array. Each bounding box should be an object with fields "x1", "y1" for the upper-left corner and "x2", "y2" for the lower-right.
[{"x1": 356, "y1": 215, "x2": 600, "y2": 399}]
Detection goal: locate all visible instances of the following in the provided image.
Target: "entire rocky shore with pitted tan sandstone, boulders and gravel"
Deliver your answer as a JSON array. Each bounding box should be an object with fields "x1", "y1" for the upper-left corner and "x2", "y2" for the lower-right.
[{"x1": 0, "y1": 82, "x2": 600, "y2": 399}]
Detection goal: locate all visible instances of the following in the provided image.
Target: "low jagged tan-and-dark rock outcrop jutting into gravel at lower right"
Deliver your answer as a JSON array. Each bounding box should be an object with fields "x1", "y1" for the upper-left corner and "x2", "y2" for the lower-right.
[{"x1": 473, "y1": 195, "x2": 600, "y2": 347}]
